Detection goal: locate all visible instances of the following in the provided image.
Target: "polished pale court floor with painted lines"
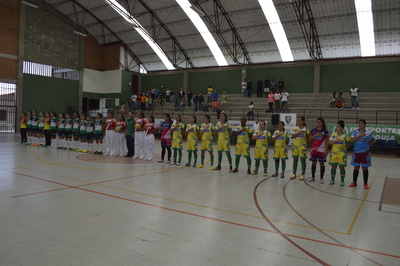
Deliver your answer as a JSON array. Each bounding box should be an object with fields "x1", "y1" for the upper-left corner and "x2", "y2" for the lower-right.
[{"x1": 0, "y1": 133, "x2": 400, "y2": 266}]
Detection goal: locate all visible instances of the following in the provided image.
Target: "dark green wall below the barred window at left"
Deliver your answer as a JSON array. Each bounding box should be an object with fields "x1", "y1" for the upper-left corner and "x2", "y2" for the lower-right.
[{"x1": 23, "y1": 74, "x2": 79, "y2": 113}]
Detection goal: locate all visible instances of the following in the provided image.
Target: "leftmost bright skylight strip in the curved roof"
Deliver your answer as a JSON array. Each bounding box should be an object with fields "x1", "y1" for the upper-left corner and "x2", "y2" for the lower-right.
[{"x1": 106, "y1": 0, "x2": 175, "y2": 70}]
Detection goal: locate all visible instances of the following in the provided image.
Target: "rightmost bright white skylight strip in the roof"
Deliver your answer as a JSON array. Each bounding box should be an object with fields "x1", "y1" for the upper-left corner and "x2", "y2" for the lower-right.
[{"x1": 354, "y1": 0, "x2": 375, "y2": 56}]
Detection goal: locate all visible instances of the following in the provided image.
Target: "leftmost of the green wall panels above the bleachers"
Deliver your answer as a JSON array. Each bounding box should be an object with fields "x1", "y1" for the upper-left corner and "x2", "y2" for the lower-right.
[{"x1": 139, "y1": 74, "x2": 183, "y2": 91}]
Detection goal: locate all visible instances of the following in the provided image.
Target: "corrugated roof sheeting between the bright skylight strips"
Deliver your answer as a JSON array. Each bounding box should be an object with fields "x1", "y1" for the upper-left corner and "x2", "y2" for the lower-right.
[{"x1": 47, "y1": 0, "x2": 400, "y2": 71}]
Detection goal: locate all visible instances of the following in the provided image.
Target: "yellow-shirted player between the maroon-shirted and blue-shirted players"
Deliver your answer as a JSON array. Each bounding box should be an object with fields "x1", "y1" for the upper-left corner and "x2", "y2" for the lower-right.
[{"x1": 328, "y1": 120, "x2": 350, "y2": 186}]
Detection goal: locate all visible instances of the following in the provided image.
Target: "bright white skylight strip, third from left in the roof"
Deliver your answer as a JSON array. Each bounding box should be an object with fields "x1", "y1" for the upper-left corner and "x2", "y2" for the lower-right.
[{"x1": 258, "y1": 0, "x2": 294, "y2": 62}]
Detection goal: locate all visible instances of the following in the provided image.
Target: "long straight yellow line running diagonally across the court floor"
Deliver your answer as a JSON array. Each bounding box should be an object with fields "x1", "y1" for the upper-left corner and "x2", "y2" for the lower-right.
[{"x1": 19, "y1": 164, "x2": 346, "y2": 234}]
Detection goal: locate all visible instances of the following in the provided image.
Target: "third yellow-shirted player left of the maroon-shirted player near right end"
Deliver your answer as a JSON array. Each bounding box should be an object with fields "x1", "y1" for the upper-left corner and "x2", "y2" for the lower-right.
[{"x1": 251, "y1": 121, "x2": 271, "y2": 176}]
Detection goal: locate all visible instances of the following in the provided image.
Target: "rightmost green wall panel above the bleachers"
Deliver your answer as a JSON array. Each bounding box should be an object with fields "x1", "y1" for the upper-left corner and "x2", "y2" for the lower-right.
[{"x1": 320, "y1": 62, "x2": 400, "y2": 93}]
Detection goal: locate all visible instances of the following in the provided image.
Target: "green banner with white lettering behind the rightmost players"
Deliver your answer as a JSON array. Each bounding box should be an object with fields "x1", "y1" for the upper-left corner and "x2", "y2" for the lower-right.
[{"x1": 327, "y1": 123, "x2": 400, "y2": 142}]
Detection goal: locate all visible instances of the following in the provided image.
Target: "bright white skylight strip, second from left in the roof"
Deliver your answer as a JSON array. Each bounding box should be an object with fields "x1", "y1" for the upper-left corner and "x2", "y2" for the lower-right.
[{"x1": 176, "y1": 0, "x2": 228, "y2": 66}]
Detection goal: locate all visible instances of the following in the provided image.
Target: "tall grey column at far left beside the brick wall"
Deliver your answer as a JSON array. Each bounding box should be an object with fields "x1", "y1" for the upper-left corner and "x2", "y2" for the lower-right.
[{"x1": 15, "y1": 5, "x2": 26, "y2": 132}]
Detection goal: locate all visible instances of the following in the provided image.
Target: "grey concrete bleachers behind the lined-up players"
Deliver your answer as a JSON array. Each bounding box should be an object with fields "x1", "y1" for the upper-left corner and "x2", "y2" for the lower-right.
[{"x1": 136, "y1": 92, "x2": 400, "y2": 125}]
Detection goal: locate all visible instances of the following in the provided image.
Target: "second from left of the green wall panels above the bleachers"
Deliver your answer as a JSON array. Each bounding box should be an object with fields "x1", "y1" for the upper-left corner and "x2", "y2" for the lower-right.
[{"x1": 188, "y1": 70, "x2": 242, "y2": 94}]
